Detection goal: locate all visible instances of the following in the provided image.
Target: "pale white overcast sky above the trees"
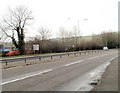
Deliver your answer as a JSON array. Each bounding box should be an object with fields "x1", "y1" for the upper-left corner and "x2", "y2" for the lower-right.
[{"x1": 0, "y1": 0, "x2": 119, "y2": 37}]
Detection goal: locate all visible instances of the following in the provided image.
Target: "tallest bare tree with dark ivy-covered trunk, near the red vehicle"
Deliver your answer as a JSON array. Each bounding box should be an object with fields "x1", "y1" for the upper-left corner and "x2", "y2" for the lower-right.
[{"x1": 0, "y1": 6, "x2": 33, "y2": 54}]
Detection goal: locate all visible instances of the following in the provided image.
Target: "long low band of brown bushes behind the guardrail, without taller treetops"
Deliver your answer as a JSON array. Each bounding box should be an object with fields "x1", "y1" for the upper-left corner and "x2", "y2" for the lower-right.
[{"x1": 26, "y1": 31, "x2": 119, "y2": 53}]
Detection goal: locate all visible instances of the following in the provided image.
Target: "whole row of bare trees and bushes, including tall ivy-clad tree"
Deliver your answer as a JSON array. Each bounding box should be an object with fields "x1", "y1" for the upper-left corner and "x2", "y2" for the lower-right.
[{"x1": 0, "y1": 6, "x2": 119, "y2": 55}]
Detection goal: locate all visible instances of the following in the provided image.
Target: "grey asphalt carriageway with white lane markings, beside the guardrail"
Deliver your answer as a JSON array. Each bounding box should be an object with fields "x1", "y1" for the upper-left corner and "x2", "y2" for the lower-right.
[{"x1": 1, "y1": 50, "x2": 118, "y2": 91}]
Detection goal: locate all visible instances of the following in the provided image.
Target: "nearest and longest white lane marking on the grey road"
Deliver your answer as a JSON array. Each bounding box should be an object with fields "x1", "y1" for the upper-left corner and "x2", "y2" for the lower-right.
[{"x1": 1, "y1": 69, "x2": 53, "y2": 85}]
